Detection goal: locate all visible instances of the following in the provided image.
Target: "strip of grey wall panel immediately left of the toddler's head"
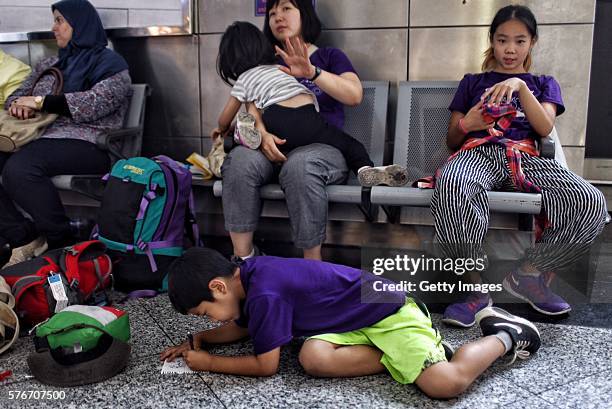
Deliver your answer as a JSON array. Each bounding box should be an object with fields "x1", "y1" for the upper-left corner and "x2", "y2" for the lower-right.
[{"x1": 200, "y1": 34, "x2": 231, "y2": 137}]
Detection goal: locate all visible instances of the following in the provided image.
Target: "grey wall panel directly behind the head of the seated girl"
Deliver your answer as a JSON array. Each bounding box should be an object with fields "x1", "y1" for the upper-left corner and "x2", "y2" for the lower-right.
[{"x1": 409, "y1": 25, "x2": 593, "y2": 146}]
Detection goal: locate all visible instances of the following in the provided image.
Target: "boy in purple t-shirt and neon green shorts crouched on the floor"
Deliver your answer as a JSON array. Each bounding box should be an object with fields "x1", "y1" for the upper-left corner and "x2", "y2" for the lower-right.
[{"x1": 161, "y1": 248, "x2": 540, "y2": 398}]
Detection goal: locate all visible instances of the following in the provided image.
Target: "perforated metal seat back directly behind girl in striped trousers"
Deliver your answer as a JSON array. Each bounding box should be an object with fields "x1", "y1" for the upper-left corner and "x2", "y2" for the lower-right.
[{"x1": 393, "y1": 81, "x2": 459, "y2": 180}]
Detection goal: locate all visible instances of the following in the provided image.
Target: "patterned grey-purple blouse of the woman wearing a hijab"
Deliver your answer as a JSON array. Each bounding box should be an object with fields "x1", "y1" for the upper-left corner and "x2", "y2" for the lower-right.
[{"x1": 5, "y1": 57, "x2": 132, "y2": 143}]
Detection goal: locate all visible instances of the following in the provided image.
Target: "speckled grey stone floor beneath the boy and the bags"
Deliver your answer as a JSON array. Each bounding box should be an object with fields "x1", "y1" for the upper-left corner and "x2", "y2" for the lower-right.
[{"x1": 0, "y1": 295, "x2": 612, "y2": 409}]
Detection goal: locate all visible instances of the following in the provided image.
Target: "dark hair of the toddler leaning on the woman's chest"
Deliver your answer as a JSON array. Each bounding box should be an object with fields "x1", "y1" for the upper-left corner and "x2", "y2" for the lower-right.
[{"x1": 217, "y1": 21, "x2": 277, "y2": 85}]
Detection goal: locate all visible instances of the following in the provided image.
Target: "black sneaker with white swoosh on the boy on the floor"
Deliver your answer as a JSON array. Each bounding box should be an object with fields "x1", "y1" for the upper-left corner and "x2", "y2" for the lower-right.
[{"x1": 476, "y1": 307, "x2": 541, "y2": 365}]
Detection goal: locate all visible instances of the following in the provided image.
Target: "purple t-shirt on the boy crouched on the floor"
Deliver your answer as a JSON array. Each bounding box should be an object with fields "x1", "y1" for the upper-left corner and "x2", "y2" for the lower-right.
[{"x1": 236, "y1": 256, "x2": 406, "y2": 355}]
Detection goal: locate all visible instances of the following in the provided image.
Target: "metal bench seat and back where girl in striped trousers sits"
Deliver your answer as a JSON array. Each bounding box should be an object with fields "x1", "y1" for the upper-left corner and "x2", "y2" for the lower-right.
[{"x1": 370, "y1": 81, "x2": 567, "y2": 222}]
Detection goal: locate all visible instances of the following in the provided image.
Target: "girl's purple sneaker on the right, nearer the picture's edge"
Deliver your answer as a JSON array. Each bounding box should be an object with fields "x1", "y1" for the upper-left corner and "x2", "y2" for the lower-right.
[{"x1": 503, "y1": 273, "x2": 572, "y2": 315}]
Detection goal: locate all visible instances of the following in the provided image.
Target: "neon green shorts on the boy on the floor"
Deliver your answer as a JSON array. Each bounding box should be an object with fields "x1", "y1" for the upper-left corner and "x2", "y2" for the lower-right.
[{"x1": 309, "y1": 298, "x2": 446, "y2": 384}]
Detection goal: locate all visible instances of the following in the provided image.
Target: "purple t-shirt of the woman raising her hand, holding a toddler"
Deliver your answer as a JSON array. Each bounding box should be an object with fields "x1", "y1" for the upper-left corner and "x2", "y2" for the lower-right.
[{"x1": 281, "y1": 47, "x2": 357, "y2": 129}]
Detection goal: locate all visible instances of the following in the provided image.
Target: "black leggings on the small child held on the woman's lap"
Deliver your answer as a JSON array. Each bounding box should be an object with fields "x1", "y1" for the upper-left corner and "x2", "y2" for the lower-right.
[{"x1": 262, "y1": 104, "x2": 374, "y2": 173}]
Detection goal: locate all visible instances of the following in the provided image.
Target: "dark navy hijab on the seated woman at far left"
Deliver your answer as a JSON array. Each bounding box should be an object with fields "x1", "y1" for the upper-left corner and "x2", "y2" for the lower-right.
[{"x1": 51, "y1": 0, "x2": 128, "y2": 93}]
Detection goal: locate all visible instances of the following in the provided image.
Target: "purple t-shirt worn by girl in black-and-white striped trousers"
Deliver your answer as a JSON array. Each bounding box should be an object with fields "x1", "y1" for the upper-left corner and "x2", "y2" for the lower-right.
[{"x1": 448, "y1": 71, "x2": 565, "y2": 140}]
